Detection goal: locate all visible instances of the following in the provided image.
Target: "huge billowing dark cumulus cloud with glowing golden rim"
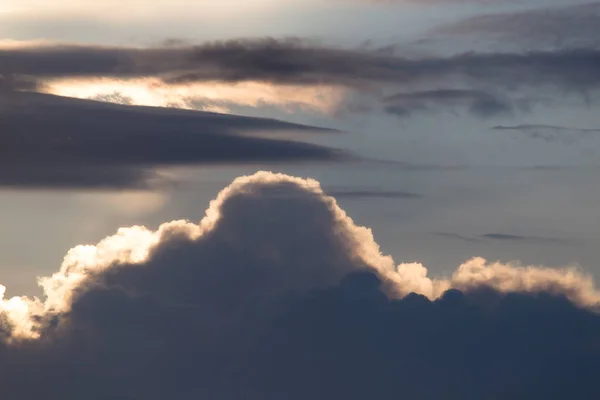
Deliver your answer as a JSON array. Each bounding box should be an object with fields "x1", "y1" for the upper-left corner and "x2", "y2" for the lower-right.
[{"x1": 0, "y1": 172, "x2": 600, "y2": 400}]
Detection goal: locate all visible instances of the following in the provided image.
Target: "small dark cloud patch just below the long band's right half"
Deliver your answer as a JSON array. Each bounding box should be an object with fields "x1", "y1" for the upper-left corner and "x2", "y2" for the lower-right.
[{"x1": 385, "y1": 89, "x2": 513, "y2": 118}]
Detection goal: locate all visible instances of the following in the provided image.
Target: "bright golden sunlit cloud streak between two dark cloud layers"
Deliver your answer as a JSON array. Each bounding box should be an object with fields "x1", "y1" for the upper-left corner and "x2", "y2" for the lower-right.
[{"x1": 46, "y1": 78, "x2": 347, "y2": 115}]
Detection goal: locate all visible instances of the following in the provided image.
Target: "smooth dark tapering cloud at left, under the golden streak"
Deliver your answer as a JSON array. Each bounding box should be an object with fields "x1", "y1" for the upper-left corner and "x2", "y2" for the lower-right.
[{"x1": 0, "y1": 92, "x2": 343, "y2": 189}]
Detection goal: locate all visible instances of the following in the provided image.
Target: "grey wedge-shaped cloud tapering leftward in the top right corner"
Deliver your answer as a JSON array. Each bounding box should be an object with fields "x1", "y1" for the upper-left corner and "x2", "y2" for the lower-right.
[{"x1": 434, "y1": 3, "x2": 600, "y2": 50}]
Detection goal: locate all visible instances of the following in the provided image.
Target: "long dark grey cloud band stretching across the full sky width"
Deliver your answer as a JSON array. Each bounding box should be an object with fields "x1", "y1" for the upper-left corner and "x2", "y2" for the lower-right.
[{"x1": 0, "y1": 39, "x2": 600, "y2": 89}]
